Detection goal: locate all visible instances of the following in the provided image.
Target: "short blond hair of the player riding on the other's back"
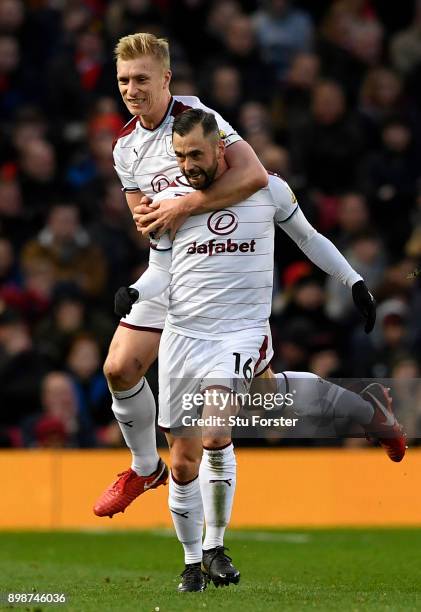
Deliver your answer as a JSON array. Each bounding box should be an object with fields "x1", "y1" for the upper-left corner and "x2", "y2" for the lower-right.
[{"x1": 114, "y1": 32, "x2": 170, "y2": 70}]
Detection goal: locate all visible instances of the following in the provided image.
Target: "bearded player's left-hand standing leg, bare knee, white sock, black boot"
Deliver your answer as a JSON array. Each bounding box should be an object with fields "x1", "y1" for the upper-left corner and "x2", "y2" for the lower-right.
[{"x1": 166, "y1": 434, "x2": 206, "y2": 593}]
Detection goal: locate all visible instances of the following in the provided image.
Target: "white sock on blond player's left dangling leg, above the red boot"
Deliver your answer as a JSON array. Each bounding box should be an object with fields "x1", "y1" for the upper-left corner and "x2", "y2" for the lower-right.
[{"x1": 111, "y1": 378, "x2": 159, "y2": 476}]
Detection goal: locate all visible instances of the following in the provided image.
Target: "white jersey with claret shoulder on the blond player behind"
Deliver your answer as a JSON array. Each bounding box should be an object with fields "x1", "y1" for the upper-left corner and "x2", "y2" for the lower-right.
[{"x1": 113, "y1": 96, "x2": 242, "y2": 198}]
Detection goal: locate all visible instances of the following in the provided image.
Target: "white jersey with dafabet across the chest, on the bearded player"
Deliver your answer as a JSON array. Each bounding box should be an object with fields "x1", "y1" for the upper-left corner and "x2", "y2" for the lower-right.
[{"x1": 152, "y1": 176, "x2": 298, "y2": 339}]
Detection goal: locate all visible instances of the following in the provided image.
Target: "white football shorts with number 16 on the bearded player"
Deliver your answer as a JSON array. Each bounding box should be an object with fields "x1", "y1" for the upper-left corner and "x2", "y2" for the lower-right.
[{"x1": 158, "y1": 326, "x2": 273, "y2": 430}]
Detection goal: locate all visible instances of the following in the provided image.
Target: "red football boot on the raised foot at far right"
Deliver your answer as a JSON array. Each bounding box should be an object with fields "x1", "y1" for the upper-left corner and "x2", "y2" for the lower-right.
[{"x1": 360, "y1": 383, "x2": 407, "y2": 461}]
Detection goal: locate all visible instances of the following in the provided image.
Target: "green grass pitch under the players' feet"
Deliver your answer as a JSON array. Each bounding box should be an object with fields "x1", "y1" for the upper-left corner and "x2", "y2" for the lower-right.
[{"x1": 0, "y1": 529, "x2": 421, "y2": 612}]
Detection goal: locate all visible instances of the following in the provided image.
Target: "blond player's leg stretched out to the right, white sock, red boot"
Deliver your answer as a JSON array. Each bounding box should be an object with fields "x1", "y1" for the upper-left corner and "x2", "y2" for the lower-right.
[{"x1": 275, "y1": 372, "x2": 406, "y2": 461}]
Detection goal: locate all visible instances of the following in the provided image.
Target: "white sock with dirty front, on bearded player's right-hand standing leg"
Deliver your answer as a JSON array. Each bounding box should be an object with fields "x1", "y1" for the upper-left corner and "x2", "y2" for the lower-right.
[{"x1": 199, "y1": 444, "x2": 237, "y2": 550}]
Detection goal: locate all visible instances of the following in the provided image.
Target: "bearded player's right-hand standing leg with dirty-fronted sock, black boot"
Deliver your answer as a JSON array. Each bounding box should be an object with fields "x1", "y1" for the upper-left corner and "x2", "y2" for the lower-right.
[{"x1": 199, "y1": 389, "x2": 240, "y2": 587}]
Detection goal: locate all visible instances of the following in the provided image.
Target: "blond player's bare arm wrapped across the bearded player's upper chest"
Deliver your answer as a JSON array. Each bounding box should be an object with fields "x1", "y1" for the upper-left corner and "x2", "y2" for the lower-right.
[{"x1": 134, "y1": 140, "x2": 268, "y2": 236}]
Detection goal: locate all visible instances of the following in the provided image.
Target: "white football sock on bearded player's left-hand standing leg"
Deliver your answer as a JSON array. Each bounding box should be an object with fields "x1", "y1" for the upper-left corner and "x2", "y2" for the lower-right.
[{"x1": 168, "y1": 474, "x2": 203, "y2": 564}]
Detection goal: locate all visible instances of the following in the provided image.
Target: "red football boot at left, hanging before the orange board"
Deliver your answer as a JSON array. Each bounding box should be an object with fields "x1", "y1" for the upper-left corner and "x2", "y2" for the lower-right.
[{"x1": 94, "y1": 459, "x2": 168, "y2": 518}]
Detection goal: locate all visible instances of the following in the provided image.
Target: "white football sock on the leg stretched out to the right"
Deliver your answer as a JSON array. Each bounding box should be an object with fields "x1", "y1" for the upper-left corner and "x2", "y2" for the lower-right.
[{"x1": 275, "y1": 372, "x2": 374, "y2": 426}]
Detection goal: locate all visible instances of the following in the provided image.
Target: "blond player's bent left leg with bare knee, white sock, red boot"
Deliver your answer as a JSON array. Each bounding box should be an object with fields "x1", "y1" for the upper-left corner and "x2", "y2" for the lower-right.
[{"x1": 94, "y1": 326, "x2": 168, "y2": 517}]
